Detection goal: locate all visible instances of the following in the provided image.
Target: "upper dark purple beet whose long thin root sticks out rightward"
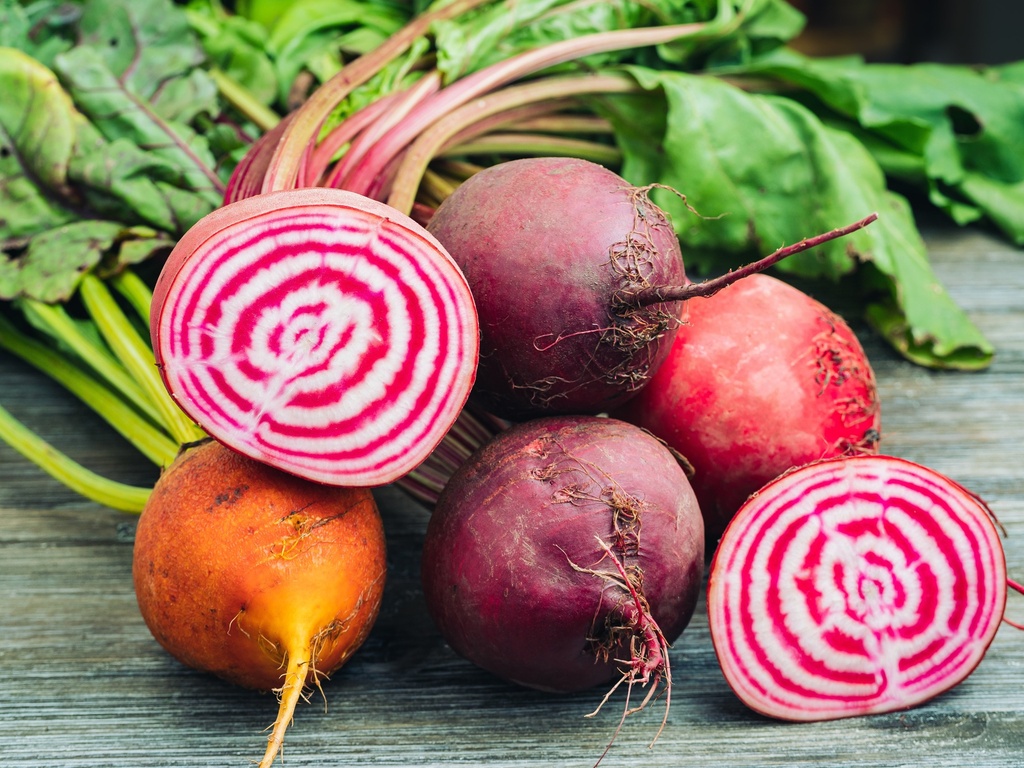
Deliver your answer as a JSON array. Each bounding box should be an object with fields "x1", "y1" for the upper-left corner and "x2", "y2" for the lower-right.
[{"x1": 428, "y1": 158, "x2": 686, "y2": 420}]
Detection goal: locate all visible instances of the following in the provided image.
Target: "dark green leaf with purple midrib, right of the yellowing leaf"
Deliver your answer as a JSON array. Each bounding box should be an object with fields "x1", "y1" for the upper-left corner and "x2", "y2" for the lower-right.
[{"x1": 56, "y1": 0, "x2": 222, "y2": 232}]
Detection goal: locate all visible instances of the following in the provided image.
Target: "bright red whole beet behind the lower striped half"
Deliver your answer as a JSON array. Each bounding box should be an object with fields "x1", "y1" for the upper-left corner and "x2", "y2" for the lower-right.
[{"x1": 614, "y1": 274, "x2": 881, "y2": 550}]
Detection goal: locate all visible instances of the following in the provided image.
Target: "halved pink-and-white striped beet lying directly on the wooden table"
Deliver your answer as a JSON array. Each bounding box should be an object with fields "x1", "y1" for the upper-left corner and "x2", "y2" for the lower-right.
[{"x1": 708, "y1": 456, "x2": 1007, "y2": 721}]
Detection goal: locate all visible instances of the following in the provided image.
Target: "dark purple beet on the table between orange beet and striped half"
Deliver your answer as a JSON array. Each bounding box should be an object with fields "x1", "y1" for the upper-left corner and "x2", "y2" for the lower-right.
[{"x1": 423, "y1": 416, "x2": 703, "y2": 691}]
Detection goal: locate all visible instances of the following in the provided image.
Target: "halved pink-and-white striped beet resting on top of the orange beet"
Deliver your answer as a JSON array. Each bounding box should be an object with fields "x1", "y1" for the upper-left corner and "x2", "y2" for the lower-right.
[{"x1": 151, "y1": 187, "x2": 478, "y2": 486}]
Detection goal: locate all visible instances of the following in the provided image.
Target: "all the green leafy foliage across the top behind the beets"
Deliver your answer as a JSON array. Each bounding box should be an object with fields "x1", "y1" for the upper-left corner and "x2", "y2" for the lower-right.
[{"x1": 0, "y1": 0, "x2": 1024, "y2": 368}]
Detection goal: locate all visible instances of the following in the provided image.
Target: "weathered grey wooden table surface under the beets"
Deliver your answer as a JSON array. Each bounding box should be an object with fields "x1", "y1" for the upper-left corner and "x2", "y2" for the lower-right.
[{"x1": 0, "y1": 219, "x2": 1024, "y2": 768}]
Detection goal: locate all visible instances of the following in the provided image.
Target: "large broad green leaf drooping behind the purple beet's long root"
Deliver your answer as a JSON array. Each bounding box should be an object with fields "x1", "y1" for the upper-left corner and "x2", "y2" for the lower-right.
[{"x1": 608, "y1": 68, "x2": 992, "y2": 368}]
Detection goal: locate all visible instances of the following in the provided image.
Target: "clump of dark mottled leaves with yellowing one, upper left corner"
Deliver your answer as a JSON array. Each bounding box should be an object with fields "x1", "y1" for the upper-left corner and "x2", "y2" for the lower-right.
[{"x1": 0, "y1": 0, "x2": 233, "y2": 301}]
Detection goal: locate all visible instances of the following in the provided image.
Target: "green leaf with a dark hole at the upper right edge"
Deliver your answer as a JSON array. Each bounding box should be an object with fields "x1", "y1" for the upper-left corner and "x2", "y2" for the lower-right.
[{"x1": 733, "y1": 51, "x2": 1024, "y2": 245}]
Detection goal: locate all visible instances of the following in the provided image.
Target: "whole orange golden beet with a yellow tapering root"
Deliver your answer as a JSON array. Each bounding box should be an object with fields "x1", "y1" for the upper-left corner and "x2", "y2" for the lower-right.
[{"x1": 132, "y1": 440, "x2": 387, "y2": 768}]
